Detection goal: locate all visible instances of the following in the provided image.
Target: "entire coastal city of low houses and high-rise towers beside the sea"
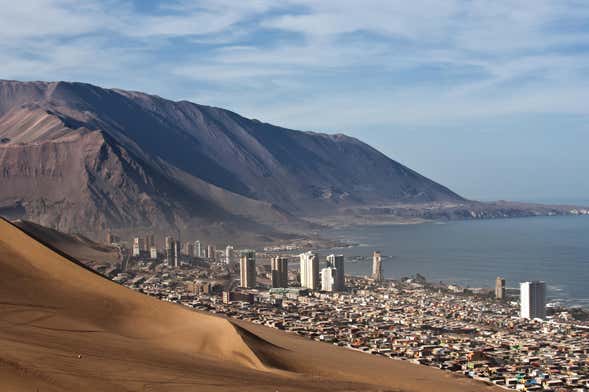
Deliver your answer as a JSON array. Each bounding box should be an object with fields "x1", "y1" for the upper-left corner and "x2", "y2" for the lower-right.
[{"x1": 102, "y1": 235, "x2": 589, "y2": 391}]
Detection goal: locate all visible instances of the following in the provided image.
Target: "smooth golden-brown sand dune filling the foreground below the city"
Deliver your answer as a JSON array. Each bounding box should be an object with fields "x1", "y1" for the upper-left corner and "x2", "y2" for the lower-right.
[{"x1": 0, "y1": 220, "x2": 496, "y2": 392}]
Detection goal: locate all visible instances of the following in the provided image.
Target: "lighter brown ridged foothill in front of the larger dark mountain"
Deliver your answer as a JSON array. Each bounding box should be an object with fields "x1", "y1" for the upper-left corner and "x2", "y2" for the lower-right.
[{"x1": 0, "y1": 115, "x2": 310, "y2": 239}]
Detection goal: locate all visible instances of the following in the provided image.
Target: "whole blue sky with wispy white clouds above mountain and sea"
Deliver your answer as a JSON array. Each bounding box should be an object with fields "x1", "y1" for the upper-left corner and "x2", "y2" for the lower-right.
[{"x1": 0, "y1": 0, "x2": 589, "y2": 204}]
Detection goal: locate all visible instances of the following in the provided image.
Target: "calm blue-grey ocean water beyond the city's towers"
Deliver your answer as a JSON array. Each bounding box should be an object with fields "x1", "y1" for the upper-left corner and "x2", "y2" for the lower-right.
[{"x1": 321, "y1": 216, "x2": 589, "y2": 309}]
